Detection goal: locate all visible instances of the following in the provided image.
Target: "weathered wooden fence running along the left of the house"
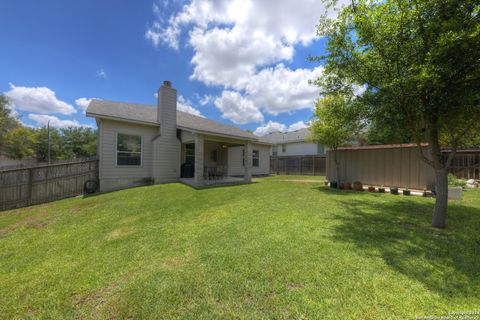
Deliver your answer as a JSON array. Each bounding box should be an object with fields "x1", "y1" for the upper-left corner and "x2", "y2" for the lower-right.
[{"x1": 0, "y1": 160, "x2": 98, "y2": 210}]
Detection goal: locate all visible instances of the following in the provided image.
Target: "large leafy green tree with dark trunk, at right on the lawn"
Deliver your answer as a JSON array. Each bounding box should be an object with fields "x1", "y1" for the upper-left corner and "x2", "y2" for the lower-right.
[{"x1": 315, "y1": 0, "x2": 480, "y2": 228}]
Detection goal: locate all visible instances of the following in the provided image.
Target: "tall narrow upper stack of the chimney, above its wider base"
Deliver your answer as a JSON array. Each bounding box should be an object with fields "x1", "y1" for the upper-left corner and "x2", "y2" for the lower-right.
[{"x1": 157, "y1": 80, "x2": 177, "y2": 136}]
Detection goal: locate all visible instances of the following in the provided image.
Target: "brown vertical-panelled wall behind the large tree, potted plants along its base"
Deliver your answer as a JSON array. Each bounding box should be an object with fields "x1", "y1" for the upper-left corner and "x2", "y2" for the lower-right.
[{"x1": 327, "y1": 144, "x2": 480, "y2": 190}]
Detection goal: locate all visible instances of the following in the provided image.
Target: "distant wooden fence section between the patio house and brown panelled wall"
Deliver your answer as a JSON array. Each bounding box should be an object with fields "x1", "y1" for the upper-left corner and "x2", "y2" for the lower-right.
[{"x1": 270, "y1": 155, "x2": 326, "y2": 176}]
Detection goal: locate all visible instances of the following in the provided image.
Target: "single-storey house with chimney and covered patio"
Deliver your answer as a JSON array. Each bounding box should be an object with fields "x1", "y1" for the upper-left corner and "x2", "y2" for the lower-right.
[{"x1": 86, "y1": 81, "x2": 270, "y2": 191}]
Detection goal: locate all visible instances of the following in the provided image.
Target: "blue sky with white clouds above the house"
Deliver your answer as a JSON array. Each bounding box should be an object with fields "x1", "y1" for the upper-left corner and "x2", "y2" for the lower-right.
[{"x1": 0, "y1": 0, "x2": 332, "y2": 134}]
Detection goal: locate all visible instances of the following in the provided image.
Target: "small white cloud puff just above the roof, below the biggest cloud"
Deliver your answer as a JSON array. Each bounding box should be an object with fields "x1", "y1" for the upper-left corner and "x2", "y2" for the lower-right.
[{"x1": 214, "y1": 90, "x2": 263, "y2": 124}]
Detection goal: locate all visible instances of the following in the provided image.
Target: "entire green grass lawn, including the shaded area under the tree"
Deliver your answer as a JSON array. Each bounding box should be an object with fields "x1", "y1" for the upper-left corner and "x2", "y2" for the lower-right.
[{"x1": 0, "y1": 176, "x2": 480, "y2": 319}]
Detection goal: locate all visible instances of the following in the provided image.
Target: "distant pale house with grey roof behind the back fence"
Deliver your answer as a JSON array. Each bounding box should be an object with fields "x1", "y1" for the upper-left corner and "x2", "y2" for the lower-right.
[{"x1": 259, "y1": 128, "x2": 325, "y2": 156}]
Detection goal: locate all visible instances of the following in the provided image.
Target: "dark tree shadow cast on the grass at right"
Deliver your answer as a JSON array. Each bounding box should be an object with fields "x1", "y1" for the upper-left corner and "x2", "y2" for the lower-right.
[{"x1": 321, "y1": 190, "x2": 480, "y2": 298}]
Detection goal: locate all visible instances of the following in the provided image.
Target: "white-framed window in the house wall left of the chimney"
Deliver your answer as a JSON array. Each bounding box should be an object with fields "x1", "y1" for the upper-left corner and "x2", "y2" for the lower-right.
[{"x1": 117, "y1": 133, "x2": 143, "y2": 166}]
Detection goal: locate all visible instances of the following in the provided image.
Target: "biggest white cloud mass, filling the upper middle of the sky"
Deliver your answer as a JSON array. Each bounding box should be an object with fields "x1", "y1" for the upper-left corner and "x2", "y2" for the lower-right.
[{"x1": 145, "y1": 0, "x2": 346, "y2": 123}]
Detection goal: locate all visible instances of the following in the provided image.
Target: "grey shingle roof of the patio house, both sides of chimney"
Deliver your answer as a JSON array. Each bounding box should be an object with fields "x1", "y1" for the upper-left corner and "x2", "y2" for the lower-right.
[{"x1": 86, "y1": 99, "x2": 258, "y2": 140}]
